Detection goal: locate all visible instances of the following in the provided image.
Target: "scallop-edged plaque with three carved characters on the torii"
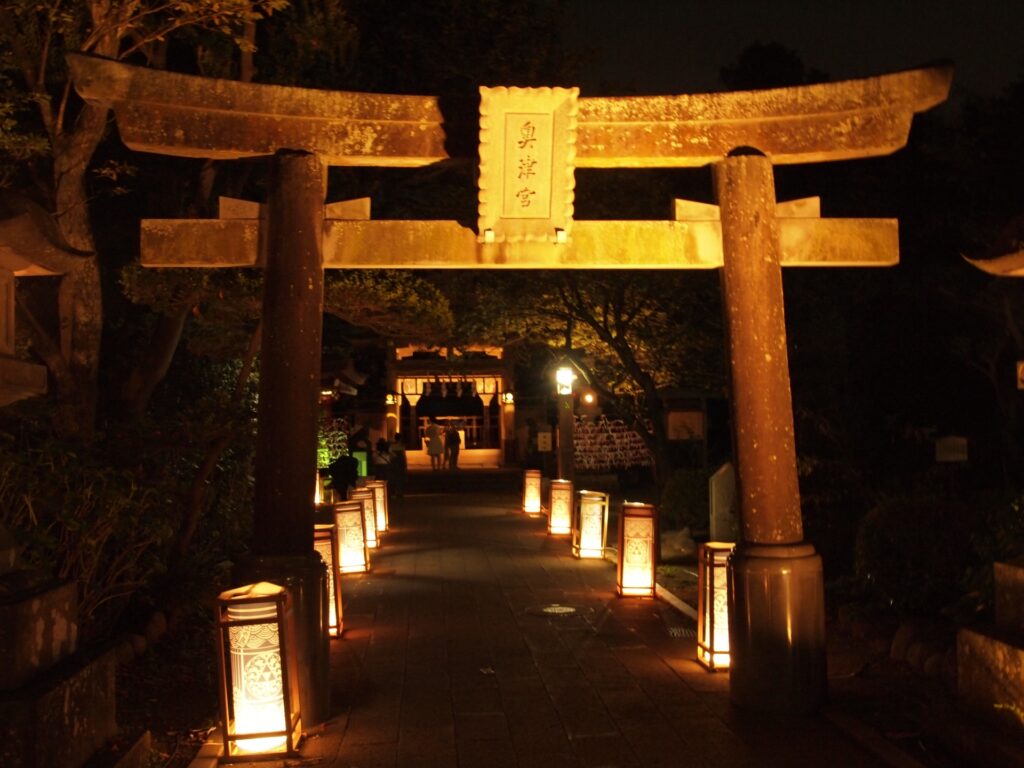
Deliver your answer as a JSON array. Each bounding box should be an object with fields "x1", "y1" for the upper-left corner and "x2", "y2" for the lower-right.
[{"x1": 477, "y1": 88, "x2": 580, "y2": 243}]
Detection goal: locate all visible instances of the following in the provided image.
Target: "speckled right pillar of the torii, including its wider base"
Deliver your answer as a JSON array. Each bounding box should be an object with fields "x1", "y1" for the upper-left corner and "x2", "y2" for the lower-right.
[{"x1": 714, "y1": 153, "x2": 827, "y2": 713}]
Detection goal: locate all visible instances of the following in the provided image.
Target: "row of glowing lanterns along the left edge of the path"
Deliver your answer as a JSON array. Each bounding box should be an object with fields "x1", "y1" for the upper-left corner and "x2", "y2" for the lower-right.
[{"x1": 217, "y1": 479, "x2": 388, "y2": 763}]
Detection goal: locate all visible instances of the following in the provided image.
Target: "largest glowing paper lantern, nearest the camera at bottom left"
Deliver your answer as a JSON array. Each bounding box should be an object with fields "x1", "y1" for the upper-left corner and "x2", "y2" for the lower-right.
[{"x1": 217, "y1": 582, "x2": 302, "y2": 763}]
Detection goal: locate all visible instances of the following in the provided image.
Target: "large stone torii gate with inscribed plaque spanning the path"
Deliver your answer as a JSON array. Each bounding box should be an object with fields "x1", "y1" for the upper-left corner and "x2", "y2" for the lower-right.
[{"x1": 70, "y1": 55, "x2": 952, "y2": 722}]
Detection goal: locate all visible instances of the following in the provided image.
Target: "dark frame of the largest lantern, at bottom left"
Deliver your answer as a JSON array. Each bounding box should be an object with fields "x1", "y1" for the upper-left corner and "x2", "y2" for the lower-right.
[{"x1": 217, "y1": 582, "x2": 302, "y2": 763}]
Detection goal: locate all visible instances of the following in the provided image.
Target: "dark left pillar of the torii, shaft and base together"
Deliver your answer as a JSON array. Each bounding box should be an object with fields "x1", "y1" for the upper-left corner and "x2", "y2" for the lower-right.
[{"x1": 234, "y1": 151, "x2": 330, "y2": 728}]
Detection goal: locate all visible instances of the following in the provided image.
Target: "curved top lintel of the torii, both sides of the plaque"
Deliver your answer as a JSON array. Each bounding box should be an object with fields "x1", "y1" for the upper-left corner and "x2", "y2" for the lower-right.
[{"x1": 68, "y1": 54, "x2": 952, "y2": 168}]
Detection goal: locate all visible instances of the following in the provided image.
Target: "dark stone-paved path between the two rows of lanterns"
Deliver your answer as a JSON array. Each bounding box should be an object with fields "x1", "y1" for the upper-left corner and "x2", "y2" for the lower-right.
[{"x1": 197, "y1": 494, "x2": 885, "y2": 768}]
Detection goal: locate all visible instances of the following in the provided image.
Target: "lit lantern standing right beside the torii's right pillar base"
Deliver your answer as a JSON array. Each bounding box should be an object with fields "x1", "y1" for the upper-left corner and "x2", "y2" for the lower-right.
[{"x1": 697, "y1": 542, "x2": 736, "y2": 672}]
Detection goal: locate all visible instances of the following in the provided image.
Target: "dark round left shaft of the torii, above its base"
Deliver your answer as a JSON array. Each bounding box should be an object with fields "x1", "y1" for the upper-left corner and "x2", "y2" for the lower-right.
[{"x1": 254, "y1": 152, "x2": 326, "y2": 555}]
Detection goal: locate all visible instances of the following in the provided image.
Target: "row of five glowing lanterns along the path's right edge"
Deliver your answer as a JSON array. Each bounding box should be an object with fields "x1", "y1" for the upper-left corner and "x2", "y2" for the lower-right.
[{"x1": 522, "y1": 469, "x2": 735, "y2": 672}]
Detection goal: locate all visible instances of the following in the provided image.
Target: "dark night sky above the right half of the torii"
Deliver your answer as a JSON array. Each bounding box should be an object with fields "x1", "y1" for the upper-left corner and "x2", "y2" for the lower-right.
[{"x1": 569, "y1": 0, "x2": 1024, "y2": 100}]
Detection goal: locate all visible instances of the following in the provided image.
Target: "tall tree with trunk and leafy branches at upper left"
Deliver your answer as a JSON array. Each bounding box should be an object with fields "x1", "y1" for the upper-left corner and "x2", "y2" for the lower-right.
[{"x1": 0, "y1": 0, "x2": 285, "y2": 440}]
